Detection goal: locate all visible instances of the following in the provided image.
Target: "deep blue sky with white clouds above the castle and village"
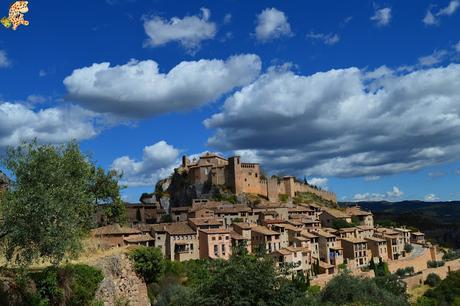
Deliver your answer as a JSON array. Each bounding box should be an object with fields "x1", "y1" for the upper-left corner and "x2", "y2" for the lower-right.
[{"x1": 0, "y1": 0, "x2": 460, "y2": 201}]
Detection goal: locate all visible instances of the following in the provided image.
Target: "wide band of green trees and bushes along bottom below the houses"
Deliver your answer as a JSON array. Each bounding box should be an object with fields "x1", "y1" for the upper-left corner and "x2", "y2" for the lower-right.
[{"x1": 126, "y1": 245, "x2": 408, "y2": 306}]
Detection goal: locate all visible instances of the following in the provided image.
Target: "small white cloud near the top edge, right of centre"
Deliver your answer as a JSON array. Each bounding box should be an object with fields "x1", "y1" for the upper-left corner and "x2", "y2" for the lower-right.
[{"x1": 255, "y1": 8, "x2": 292, "y2": 42}]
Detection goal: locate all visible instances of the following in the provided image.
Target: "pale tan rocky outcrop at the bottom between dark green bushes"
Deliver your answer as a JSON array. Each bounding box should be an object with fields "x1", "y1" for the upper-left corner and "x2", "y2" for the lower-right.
[{"x1": 94, "y1": 254, "x2": 150, "y2": 306}]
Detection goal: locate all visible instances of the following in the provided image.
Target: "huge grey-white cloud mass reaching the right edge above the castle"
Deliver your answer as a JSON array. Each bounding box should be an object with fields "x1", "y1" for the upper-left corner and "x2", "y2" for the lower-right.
[{"x1": 204, "y1": 64, "x2": 460, "y2": 177}]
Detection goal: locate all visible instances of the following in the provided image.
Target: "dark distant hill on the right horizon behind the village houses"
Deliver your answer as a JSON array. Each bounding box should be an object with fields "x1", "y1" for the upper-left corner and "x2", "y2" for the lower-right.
[{"x1": 339, "y1": 201, "x2": 460, "y2": 248}]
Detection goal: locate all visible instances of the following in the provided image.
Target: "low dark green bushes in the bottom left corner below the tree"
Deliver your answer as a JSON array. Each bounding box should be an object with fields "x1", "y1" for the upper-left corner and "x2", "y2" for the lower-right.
[{"x1": 0, "y1": 265, "x2": 104, "y2": 306}]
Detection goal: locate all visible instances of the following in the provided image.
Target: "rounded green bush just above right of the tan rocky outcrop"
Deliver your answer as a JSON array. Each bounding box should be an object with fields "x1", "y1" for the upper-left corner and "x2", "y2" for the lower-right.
[{"x1": 129, "y1": 247, "x2": 165, "y2": 284}]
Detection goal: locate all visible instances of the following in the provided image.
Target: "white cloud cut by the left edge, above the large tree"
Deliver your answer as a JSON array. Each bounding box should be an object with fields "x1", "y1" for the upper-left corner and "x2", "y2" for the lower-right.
[{"x1": 0, "y1": 102, "x2": 98, "y2": 148}]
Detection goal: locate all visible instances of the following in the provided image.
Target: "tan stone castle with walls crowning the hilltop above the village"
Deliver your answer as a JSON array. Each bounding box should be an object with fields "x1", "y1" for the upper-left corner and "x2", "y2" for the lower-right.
[{"x1": 180, "y1": 153, "x2": 337, "y2": 203}]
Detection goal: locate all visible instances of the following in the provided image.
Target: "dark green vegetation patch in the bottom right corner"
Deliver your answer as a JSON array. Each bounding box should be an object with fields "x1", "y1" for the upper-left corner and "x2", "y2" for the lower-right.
[{"x1": 417, "y1": 271, "x2": 460, "y2": 306}]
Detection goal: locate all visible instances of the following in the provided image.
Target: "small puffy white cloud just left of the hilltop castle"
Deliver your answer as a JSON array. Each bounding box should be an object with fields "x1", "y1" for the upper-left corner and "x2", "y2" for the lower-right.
[{"x1": 111, "y1": 140, "x2": 179, "y2": 187}]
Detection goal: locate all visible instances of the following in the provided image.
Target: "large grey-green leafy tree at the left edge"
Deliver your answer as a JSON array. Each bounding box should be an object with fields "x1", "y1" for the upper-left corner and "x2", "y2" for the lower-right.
[{"x1": 0, "y1": 142, "x2": 119, "y2": 265}]
